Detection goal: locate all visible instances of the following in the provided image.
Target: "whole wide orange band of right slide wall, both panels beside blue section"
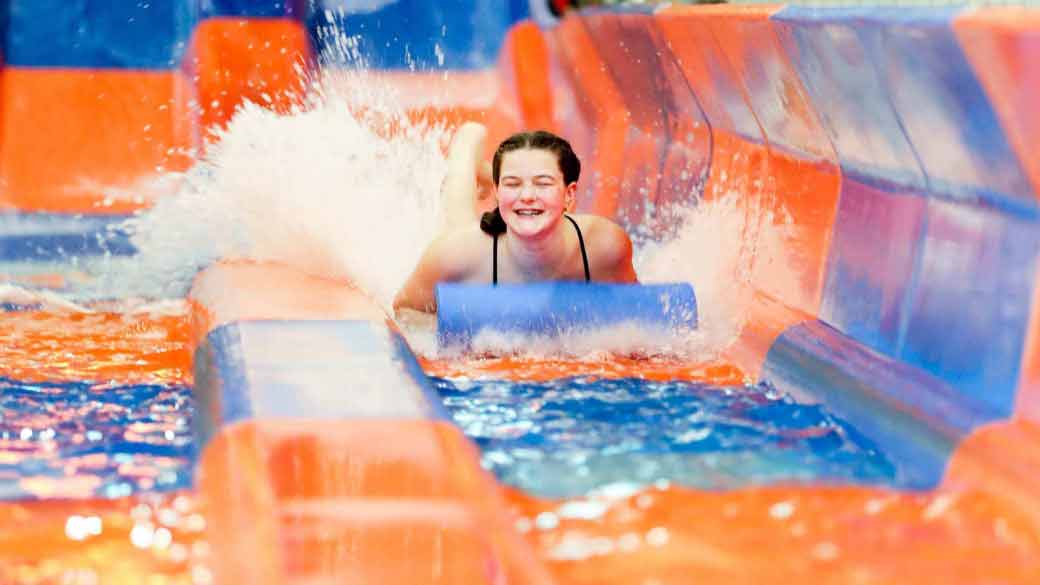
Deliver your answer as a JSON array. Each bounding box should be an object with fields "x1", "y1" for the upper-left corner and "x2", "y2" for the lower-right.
[{"x1": 656, "y1": 5, "x2": 840, "y2": 377}]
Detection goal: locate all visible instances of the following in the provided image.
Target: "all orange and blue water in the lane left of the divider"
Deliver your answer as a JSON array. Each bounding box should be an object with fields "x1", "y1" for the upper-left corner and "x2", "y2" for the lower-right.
[{"x1": 0, "y1": 303, "x2": 202, "y2": 585}]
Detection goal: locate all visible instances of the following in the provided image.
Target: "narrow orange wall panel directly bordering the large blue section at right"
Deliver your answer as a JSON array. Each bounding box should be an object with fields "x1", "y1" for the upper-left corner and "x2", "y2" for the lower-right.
[{"x1": 706, "y1": 6, "x2": 840, "y2": 314}]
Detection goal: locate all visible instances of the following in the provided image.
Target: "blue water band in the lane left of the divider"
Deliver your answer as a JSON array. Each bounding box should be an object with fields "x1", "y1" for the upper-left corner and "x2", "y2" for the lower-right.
[{"x1": 0, "y1": 378, "x2": 193, "y2": 500}]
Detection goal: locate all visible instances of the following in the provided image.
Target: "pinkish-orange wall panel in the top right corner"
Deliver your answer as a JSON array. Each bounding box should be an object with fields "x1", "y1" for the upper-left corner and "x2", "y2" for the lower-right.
[{"x1": 954, "y1": 7, "x2": 1040, "y2": 197}]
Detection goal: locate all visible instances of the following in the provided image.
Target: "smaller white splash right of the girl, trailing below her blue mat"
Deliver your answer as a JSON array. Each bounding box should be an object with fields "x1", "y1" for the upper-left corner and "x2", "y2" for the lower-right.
[{"x1": 409, "y1": 190, "x2": 799, "y2": 361}]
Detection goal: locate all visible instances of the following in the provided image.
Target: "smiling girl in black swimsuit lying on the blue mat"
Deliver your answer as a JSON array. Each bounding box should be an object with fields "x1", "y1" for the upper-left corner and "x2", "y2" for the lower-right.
[{"x1": 394, "y1": 123, "x2": 636, "y2": 312}]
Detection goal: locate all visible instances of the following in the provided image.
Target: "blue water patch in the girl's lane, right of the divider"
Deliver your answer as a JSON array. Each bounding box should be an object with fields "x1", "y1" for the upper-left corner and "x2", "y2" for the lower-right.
[{"x1": 432, "y1": 377, "x2": 895, "y2": 498}]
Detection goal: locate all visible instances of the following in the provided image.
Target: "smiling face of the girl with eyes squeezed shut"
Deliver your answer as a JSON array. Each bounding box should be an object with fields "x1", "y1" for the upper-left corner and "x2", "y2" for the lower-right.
[{"x1": 497, "y1": 149, "x2": 577, "y2": 237}]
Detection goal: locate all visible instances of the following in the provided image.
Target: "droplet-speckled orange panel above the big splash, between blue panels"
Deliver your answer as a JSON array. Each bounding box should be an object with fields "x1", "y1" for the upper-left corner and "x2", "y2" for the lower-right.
[{"x1": 187, "y1": 18, "x2": 313, "y2": 134}]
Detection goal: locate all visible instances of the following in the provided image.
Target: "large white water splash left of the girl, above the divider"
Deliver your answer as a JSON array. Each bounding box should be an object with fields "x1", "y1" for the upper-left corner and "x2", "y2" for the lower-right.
[{"x1": 100, "y1": 65, "x2": 445, "y2": 307}]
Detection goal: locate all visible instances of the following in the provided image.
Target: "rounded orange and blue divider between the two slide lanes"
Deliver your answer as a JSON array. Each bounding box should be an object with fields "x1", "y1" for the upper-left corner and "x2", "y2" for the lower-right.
[{"x1": 191, "y1": 263, "x2": 551, "y2": 584}]
